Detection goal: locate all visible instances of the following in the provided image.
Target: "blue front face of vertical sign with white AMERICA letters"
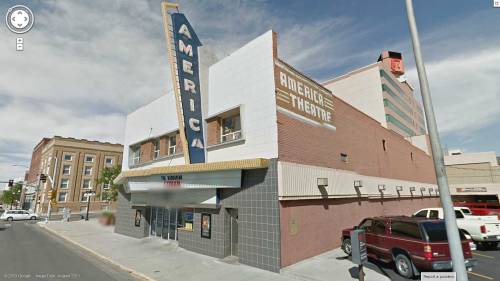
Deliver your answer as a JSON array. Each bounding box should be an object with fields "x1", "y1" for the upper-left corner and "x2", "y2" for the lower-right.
[{"x1": 172, "y1": 13, "x2": 205, "y2": 163}]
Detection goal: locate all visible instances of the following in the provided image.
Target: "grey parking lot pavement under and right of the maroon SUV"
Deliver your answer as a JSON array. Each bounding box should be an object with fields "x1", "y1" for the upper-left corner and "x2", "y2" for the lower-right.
[{"x1": 358, "y1": 245, "x2": 500, "y2": 281}]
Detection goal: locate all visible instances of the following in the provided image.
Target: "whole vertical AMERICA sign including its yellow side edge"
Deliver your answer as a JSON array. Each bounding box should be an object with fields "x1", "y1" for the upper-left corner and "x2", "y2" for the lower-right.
[{"x1": 162, "y1": 2, "x2": 205, "y2": 164}]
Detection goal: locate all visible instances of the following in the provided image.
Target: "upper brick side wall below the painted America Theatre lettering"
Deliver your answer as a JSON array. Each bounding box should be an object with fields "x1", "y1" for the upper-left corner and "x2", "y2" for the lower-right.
[{"x1": 277, "y1": 94, "x2": 436, "y2": 183}]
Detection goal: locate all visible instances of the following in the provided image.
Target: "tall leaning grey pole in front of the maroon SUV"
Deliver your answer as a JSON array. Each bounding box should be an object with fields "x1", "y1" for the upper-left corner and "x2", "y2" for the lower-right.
[{"x1": 406, "y1": 0, "x2": 469, "y2": 281}]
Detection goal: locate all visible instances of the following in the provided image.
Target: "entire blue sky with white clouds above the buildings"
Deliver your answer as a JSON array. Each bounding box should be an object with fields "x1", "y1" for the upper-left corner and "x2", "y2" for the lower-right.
[{"x1": 0, "y1": 0, "x2": 500, "y2": 180}]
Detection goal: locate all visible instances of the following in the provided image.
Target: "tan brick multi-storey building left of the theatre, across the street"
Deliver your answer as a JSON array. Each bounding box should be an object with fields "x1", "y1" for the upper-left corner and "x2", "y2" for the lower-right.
[{"x1": 25, "y1": 136, "x2": 123, "y2": 214}]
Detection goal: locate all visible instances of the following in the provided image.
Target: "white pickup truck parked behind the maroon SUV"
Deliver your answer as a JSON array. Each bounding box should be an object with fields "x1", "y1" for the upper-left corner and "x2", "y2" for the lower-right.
[{"x1": 413, "y1": 207, "x2": 500, "y2": 248}]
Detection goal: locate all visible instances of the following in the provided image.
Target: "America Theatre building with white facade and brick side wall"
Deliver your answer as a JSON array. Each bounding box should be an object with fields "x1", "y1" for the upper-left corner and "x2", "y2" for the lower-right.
[{"x1": 115, "y1": 5, "x2": 439, "y2": 272}]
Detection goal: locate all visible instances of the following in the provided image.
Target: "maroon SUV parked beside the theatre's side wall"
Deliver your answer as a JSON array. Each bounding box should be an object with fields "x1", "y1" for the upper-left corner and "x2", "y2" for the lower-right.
[{"x1": 342, "y1": 217, "x2": 477, "y2": 278}]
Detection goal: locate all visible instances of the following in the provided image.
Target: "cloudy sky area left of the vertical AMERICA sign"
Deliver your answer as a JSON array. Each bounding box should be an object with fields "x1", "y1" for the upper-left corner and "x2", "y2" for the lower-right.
[{"x1": 0, "y1": 0, "x2": 171, "y2": 179}]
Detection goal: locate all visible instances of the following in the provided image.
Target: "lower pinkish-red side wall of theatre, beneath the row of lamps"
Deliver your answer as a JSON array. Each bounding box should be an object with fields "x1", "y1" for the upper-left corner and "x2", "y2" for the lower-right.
[{"x1": 280, "y1": 197, "x2": 439, "y2": 267}]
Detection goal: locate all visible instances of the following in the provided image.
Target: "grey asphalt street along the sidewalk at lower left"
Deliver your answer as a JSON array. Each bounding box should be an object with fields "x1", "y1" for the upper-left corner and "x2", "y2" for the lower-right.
[{"x1": 0, "y1": 221, "x2": 137, "y2": 281}]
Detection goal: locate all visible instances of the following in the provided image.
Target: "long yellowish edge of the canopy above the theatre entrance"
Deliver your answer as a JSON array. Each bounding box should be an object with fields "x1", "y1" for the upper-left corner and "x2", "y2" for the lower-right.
[{"x1": 114, "y1": 158, "x2": 269, "y2": 184}]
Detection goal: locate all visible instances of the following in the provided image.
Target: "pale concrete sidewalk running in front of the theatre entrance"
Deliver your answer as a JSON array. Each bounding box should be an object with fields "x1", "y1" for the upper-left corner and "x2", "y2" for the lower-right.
[{"x1": 39, "y1": 220, "x2": 389, "y2": 281}]
